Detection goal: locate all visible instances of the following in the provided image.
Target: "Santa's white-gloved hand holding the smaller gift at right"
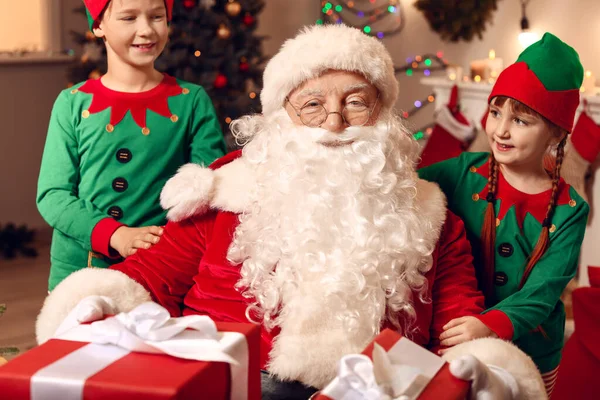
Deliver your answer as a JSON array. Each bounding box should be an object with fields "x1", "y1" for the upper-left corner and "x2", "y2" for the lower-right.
[{"x1": 450, "y1": 354, "x2": 519, "y2": 400}]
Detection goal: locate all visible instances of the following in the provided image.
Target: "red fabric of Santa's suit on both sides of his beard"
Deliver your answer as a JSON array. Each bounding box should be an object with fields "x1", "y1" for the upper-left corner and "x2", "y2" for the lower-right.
[{"x1": 113, "y1": 155, "x2": 484, "y2": 367}]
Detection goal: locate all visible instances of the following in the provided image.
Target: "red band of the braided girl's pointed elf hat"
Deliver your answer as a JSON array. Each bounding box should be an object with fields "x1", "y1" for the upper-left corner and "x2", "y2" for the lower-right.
[{"x1": 488, "y1": 61, "x2": 579, "y2": 132}]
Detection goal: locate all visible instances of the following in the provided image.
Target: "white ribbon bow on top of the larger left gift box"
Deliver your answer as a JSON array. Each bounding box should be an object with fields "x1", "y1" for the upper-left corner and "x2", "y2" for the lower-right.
[{"x1": 57, "y1": 302, "x2": 239, "y2": 365}]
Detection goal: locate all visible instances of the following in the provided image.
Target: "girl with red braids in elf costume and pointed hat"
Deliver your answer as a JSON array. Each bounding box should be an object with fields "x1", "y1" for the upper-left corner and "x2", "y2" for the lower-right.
[{"x1": 419, "y1": 33, "x2": 589, "y2": 393}]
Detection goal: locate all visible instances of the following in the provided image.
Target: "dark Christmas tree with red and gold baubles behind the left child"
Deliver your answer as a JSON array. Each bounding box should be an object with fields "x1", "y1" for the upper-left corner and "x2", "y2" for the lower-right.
[{"x1": 69, "y1": 0, "x2": 266, "y2": 150}]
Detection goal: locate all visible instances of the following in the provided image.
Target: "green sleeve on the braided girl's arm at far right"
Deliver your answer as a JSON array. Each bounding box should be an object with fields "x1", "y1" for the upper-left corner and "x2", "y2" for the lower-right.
[{"x1": 487, "y1": 201, "x2": 589, "y2": 340}]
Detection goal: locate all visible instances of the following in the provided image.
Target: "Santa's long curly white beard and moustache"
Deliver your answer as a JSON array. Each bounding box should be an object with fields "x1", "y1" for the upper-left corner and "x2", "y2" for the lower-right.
[{"x1": 228, "y1": 114, "x2": 437, "y2": 387}]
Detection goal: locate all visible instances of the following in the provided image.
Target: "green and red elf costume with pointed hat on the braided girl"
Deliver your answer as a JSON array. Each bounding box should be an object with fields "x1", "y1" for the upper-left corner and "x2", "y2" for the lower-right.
[{"x1": 419, "y1": 33, "x2": 589, "y2": 383}]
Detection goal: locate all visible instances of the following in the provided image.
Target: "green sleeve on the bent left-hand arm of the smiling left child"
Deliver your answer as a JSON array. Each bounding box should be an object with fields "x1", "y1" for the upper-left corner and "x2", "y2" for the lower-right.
[{"x1": 36, "y1": 91, "x2": 108, "y2": 249}]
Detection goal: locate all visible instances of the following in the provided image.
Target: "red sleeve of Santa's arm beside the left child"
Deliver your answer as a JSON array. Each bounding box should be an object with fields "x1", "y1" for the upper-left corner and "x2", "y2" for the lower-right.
[{"x1": 111, "y1": 212, "x2": 216, "y2": 317}]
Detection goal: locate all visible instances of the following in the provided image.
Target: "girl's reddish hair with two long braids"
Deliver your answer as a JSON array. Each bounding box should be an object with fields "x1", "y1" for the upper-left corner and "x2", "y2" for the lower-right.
[{"x1": 481, "y1": 96, "x2": 567, "y2": 304}]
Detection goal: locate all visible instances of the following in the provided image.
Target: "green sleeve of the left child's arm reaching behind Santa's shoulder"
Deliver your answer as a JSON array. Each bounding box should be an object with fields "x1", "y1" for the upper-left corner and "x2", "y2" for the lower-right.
[{"x1": 189, "y1": 88, "x2": 225, "y2": 166}]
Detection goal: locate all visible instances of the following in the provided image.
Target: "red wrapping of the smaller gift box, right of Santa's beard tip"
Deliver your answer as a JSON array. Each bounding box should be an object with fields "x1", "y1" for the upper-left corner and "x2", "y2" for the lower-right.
[{"x1": 313, "y1": 329, "x2": 471, "y2": 400}]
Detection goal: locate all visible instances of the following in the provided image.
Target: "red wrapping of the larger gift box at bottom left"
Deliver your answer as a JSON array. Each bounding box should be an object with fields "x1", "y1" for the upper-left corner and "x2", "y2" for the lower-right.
[{"x1": 0, "y1": 322, "x2": 261, "y2": 400}]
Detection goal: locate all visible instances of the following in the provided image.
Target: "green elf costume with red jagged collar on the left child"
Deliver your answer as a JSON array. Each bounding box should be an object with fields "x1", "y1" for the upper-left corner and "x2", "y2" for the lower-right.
[{"x1": 37, "y1": 0, "x2": 225, "y2": 290}]
